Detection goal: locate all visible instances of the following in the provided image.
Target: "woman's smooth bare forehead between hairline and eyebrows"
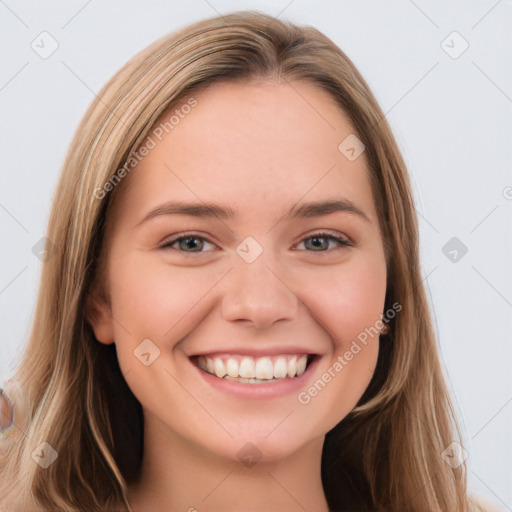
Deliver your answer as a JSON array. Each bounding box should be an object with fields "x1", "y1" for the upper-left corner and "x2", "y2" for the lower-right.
[{"x1": 113, "y1": 78, "x2": 374, "y2": 226}]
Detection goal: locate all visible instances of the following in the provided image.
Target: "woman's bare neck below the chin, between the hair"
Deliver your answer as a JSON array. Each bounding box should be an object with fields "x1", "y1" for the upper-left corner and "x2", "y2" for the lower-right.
[{"x1": 129, "y1": 414, "x2": 328, "y2": 512}]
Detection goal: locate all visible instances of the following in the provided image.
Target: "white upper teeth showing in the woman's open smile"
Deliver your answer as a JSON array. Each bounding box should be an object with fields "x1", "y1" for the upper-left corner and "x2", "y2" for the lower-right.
[{"x1": 198, "y1": 355, "x2": 308, "y2": 380}]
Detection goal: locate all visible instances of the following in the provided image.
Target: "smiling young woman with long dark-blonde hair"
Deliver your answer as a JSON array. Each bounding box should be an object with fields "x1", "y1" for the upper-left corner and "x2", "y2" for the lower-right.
[{"x1": 0, "y1": 12, "x2": 496, "y2": 512}]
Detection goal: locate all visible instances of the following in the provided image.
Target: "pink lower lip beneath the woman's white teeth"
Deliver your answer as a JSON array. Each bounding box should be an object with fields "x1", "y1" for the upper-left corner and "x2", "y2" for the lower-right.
[{"x1": 191, "y1": 356, "x2": 320, "y2": 400}]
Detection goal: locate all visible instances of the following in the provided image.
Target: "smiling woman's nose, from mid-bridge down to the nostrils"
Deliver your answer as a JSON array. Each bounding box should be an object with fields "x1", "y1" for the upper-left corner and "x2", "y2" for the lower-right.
[{"x1": 221, "y1": 252, "x2": 299, "y2": 329}]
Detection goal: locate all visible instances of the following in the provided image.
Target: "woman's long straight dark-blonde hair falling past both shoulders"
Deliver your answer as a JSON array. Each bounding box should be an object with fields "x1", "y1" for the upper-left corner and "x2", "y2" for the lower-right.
[{"x1": 0, "y1": 12, "x2": 488, "y2": 512}]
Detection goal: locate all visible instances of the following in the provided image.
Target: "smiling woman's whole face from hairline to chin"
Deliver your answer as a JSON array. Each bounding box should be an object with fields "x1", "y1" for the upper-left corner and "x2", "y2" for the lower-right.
[{"x1": 88, "y1": 83, "x2": 386, "y2": 460}]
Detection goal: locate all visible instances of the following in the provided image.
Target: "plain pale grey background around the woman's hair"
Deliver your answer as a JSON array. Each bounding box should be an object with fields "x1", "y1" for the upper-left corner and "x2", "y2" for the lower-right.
[{"x1": 0, "y1": 0, "x2": 512, "y2": 510}]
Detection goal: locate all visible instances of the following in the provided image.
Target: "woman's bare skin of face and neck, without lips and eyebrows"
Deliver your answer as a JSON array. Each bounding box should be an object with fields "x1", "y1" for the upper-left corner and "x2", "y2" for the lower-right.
[{"x1": 88, "y1": 82, "x2": 386, "y2": 512}]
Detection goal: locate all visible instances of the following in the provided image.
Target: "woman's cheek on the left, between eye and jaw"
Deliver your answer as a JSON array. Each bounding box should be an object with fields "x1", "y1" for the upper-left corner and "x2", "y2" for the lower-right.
[{"x1": 105, "y1": 255, "x2": 223, "y2": 421}]
